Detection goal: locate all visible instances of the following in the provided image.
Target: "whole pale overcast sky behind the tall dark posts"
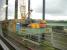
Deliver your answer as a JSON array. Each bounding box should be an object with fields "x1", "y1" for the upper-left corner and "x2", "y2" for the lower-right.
[{"x1": 0, "y1": 0, "x2": 67, "y2": 20}]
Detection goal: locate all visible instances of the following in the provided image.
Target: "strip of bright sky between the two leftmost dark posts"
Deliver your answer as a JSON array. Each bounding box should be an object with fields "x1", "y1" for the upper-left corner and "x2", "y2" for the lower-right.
[{"x1": 8, "y1": 0, "x2": 15, "y2": 19}]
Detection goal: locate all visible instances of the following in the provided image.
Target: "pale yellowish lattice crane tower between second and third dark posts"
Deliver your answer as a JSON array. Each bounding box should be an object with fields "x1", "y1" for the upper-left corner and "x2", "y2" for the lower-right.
[{"x1": 20, "y1": 0, "x2": 26, "y2": 23}]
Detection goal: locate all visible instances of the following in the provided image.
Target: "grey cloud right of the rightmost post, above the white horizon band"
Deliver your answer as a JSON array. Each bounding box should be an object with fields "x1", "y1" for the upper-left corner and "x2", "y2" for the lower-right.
[{"x1": 45, "y1": 0, "x2": 67, "y2": 15}]
